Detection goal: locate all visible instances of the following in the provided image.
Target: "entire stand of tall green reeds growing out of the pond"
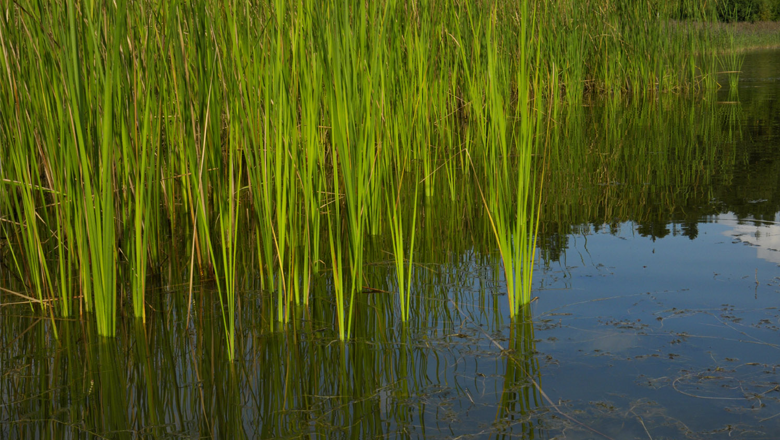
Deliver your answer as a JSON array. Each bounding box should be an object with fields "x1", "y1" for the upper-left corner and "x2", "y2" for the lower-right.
[{"x1": 0, "y1": 0, "x2": 772, "y2": 357}]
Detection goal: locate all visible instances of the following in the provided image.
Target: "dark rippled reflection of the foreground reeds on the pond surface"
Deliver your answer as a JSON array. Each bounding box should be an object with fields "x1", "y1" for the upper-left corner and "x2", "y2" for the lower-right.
[{"x1": 0, "y1": 288, "x2": 541, "y2": 438}]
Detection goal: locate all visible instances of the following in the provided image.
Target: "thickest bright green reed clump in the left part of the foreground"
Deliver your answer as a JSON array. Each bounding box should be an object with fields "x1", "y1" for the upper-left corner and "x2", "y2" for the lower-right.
[{"x1": 65, "y1": 0, "x2": 126, "y2": 336}]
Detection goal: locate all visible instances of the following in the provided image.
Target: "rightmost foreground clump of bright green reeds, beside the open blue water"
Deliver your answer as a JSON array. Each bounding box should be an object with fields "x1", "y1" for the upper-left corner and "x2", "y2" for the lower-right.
[{"x1": 480, "y1": 2, "x2": 544, "y2": 317}]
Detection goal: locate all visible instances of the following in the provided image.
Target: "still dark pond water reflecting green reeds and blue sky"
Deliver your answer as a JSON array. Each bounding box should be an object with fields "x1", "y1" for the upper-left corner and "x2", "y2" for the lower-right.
[{"x1": 0, "y1": 51, "x2": 780, "y2": 439}]
